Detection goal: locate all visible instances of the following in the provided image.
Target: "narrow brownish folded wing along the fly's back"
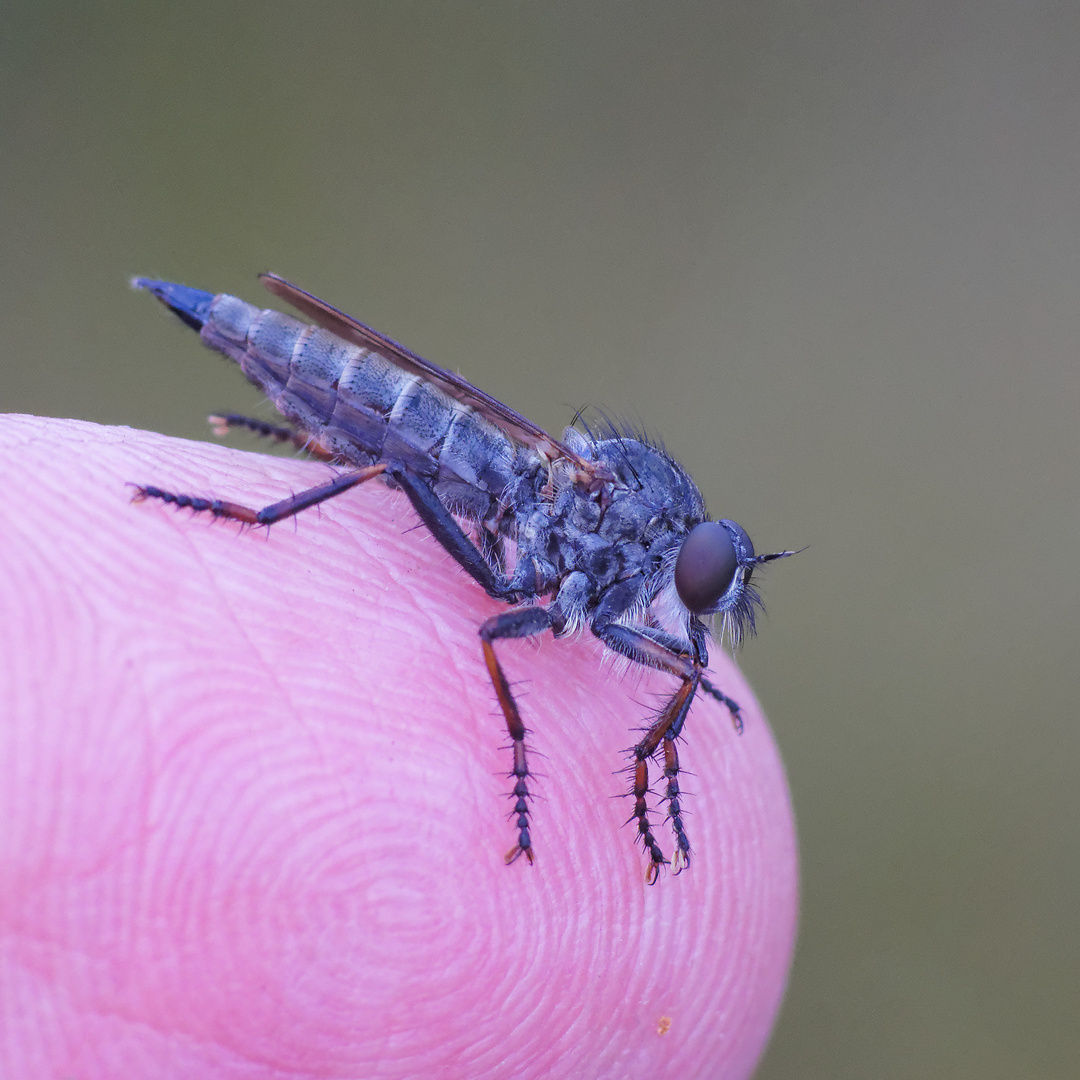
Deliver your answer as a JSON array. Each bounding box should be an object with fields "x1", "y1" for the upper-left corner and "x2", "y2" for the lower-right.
[{"x1": 259, "y1": 273, "x2": 596, "y2": 474}]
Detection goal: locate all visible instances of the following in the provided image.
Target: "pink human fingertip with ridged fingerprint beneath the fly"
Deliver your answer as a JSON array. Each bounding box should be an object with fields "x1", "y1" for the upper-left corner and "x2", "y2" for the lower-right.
[{"x1": 0, "y1": 417, "x2": 797, "y2": 1080}]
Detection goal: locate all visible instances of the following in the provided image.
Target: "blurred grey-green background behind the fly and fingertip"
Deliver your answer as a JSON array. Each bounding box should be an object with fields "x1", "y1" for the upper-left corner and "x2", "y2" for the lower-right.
[{"x1": 0, "y1": 0, "x2": 1080, "y2": 1080}]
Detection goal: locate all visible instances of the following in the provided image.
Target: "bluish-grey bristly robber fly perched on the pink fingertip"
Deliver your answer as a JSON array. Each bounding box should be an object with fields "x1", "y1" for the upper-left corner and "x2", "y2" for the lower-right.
[{"x1": 132, "y1": 273, "x2": 795, "y2": 883}]
